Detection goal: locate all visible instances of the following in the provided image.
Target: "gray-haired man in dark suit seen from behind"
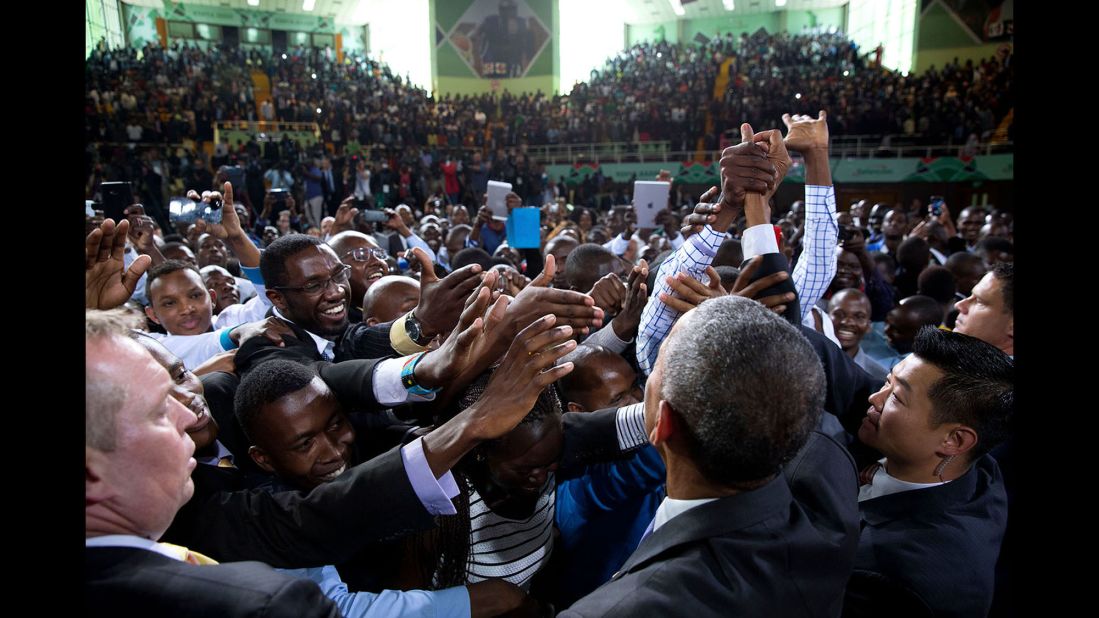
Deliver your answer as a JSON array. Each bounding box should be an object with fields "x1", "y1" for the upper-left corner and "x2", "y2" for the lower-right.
[{"x1": 562, "y1": 296, "x2": 854, "y2": 616}]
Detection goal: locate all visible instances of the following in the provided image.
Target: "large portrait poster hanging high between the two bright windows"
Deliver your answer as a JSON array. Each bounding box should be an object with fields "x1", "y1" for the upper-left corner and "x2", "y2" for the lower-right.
[{"x1": 434, "y1": 0, "x2": 554, "y2": 94}]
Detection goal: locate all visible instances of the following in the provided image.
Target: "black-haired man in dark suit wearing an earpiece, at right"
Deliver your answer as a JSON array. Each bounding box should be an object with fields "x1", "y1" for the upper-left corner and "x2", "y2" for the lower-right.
[{"x1": 844, "y1": 327, "x2": 1014, "y2": 617}]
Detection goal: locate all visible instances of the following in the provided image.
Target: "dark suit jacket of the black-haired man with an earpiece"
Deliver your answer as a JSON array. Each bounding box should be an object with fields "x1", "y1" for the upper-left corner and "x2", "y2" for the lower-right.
[{"x1": 845, "y1": 455, "x2": 1008, "y2": 618}]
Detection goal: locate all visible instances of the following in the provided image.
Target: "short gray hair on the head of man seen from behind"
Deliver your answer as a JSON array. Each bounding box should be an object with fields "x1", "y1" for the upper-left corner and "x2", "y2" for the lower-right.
[{"x1": 660, "y1": 296, "x2": 825, "y2": 489}]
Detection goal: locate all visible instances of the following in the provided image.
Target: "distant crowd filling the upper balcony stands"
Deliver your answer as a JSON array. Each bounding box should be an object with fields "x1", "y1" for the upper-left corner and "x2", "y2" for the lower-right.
[{"x1": 85, "y1": 29, "x2": 1013, "y2": 152}]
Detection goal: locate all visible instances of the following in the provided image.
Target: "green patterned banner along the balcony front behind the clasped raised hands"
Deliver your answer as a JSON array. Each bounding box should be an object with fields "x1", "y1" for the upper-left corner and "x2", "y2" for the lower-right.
[{"x1": 546, "y1": 154, "x2": 1014, "y2": 185}]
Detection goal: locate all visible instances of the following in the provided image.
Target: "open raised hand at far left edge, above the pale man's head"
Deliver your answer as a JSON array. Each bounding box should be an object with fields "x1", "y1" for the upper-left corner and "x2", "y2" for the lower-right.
[{"x1": 84, "y1": 219, "x2": 153, "y2": 309}]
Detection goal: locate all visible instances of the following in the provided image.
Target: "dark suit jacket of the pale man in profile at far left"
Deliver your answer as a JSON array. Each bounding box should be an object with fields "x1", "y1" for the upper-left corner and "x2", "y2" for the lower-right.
[{"x1": 85, "y1": 548, "x2": 340, "y2": 618}]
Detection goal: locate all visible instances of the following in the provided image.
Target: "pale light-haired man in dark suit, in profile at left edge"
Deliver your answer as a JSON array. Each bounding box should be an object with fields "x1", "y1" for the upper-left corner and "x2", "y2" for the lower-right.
[{"x1": 85, "y1": 312, "x2": 340, "y2": 617}]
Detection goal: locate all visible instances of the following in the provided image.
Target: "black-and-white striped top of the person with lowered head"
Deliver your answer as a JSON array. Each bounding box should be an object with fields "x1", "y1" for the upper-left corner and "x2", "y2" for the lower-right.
[{"x1": 466, "y1": 474, "x2": 557, "y2": 591}]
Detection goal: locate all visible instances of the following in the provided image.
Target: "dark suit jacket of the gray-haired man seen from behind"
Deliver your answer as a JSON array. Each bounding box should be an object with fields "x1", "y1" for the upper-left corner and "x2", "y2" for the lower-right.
[{"x1": 560, "y1": 468, "x2": 847, "y2": 618}]
